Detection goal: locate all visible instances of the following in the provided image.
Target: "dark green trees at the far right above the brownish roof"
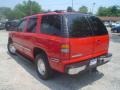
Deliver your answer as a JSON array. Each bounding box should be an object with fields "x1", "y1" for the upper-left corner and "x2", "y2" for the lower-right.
[{"x1": 97, "y1": 6, "x2": 120, "y2": 16}]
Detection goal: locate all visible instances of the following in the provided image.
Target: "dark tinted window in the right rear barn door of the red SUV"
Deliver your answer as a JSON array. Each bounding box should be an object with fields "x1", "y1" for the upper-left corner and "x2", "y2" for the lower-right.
[{"x1": 88, "y1": 16, "x2": 108, "y2": 35}]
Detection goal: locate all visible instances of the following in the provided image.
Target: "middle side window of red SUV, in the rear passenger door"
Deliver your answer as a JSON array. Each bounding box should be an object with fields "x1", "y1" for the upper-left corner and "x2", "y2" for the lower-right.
[{"x1": 27, "y1": 18, "x2": 37, "y2": 33}]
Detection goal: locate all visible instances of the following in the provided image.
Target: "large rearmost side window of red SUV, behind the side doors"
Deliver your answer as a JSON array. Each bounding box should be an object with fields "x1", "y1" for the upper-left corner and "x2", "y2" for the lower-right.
[{"x1": 40, "y1": 15, "x2": 61, "y2": 36}]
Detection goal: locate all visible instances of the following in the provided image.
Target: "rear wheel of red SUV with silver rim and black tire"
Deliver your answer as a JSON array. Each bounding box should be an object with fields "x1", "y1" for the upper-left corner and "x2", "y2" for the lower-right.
[{"x1": 35, "y1": 54, "x2": 53, "y2": 80}]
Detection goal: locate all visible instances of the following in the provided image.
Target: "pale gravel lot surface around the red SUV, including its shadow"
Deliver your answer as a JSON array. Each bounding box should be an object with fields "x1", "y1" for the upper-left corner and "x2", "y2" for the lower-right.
[{"x1": 0, "y1": 30, "x2": 120, "y2": 90}]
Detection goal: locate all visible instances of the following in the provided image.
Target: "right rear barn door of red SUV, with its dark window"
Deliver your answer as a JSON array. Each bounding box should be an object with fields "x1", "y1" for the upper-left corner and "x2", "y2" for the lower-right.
[{"x1": 88, "y1": 16, "x2": 109, "y2": 56}]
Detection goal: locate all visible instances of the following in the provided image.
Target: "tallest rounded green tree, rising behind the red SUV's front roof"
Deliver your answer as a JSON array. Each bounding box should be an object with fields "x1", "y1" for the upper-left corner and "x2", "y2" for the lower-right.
[{"x1": 13, "y1": 0, "x2": 42, "y2": 18}]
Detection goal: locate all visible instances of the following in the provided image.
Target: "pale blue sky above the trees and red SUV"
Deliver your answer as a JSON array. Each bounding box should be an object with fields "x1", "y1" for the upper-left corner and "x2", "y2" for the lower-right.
[{"x1": 0, "y1": 0, "x2": 120, "y2": 13}]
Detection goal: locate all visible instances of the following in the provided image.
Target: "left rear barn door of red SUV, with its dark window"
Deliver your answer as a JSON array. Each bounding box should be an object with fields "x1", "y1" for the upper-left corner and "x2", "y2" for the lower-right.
[{"x1": 66, "y1": 14, "x2": 94, "y2": 60}]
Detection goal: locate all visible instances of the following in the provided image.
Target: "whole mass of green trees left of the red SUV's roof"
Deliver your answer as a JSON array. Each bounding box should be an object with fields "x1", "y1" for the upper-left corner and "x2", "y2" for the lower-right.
[{"x1": 0, "y1": 0, "x2": 42, "y2": 20}]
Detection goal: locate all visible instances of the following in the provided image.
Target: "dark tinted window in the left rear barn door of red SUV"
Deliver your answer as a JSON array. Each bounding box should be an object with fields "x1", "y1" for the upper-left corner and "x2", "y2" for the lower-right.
[{"x1": 66, "y1": 14, "x2": 92, "y2": 37}]
